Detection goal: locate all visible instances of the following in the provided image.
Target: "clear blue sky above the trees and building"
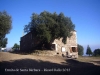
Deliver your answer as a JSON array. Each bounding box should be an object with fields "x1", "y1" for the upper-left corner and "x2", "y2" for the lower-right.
[{"x1": 0, "y1": 0, "x2": 100, "y2": 54}]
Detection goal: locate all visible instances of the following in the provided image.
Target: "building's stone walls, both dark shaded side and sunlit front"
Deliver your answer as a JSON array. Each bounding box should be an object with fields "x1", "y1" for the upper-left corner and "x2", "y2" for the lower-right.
[{"x1": 20, "y1": 31, "x2": 78, "y2": 56}]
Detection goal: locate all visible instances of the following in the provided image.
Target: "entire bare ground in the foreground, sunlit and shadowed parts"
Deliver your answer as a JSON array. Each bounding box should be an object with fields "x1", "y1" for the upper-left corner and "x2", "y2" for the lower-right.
[{"x1": 0, "y1": 52, "x2": 100, "y2": 75}]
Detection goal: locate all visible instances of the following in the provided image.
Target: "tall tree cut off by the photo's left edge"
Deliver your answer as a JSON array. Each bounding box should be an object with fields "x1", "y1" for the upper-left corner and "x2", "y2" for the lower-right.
[{"x1": 0, "y1": 11, "x2": 12, "y2": 47}]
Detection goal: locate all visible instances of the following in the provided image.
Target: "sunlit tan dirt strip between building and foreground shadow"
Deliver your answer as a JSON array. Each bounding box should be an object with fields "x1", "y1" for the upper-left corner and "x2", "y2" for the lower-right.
[{"x1": 0, "y1": 52, "x2": 66, "y2": 65}]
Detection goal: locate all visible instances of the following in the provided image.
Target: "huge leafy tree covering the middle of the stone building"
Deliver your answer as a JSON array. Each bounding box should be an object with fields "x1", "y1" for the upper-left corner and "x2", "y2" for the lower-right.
[{"x1": 24, "y1": 11, "x2": 75, "y2": 49}]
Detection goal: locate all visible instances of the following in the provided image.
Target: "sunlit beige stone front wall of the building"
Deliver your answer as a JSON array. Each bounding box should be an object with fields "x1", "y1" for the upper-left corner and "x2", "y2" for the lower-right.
[{"x1": 52, "y1": 31, "x2": 78, "y2": 55}]
